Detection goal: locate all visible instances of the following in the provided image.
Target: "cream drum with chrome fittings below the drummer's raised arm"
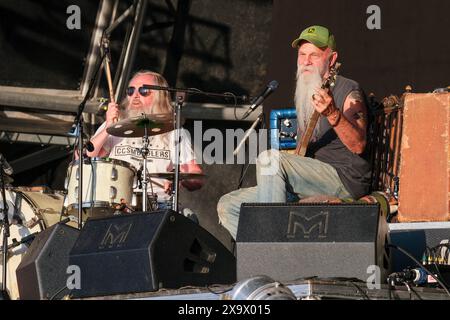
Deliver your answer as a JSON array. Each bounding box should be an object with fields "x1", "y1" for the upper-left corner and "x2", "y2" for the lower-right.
[{"x1": 65, "y1": 158, "x2": 137, "y2": 217}]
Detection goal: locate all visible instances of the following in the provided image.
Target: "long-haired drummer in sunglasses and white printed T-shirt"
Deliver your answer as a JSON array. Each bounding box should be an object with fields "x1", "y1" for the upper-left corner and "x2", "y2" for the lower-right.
[{"x1": 87, "y1": 70, "x2": 203, "y2": 203}]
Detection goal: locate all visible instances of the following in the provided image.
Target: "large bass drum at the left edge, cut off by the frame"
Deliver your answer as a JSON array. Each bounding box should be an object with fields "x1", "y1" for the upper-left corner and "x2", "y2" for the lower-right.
[{"x1": 0, "y1": 188, "x2": 64, "y2": 299}]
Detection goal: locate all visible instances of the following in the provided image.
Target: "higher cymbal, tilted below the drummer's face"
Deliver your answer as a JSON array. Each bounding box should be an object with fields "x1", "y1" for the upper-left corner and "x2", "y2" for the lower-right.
[{"x1": 106, "y1": 113, "x2": 174, "y2": 138}]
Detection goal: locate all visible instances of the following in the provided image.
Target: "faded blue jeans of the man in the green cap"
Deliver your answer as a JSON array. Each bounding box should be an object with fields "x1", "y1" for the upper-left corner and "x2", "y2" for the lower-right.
[{"x1": 217, "y1": 149, "x2": 351, "y2": 239}]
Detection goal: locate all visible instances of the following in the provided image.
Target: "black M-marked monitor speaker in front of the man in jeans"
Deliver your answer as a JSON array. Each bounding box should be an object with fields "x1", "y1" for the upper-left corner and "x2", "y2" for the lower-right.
[{"x1": 236, "y1": 203, "x2": 389, "y2": 281}]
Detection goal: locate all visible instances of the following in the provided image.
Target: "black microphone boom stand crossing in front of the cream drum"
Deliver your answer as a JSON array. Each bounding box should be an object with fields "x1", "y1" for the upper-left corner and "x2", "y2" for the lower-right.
[{"x1": 69, "y1": 47, "x2": 106, "y2": 230}]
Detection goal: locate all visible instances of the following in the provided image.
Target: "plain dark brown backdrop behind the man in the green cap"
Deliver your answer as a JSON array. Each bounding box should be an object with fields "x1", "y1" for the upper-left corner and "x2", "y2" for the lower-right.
[{"x1": 265, "y1": 0, "x2": 450, "y2": 114}]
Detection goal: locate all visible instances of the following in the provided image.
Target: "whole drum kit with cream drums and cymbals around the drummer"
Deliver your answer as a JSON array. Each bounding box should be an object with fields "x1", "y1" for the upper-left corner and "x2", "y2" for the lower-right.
[{"x1": 0, "y1": 111, "x2": 204, "y2": 299}]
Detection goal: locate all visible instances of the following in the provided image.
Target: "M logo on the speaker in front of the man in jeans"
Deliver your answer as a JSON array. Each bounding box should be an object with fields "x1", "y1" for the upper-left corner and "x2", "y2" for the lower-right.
[{"x1": 287, "y1": 211, "x2": 329, "y2": 239}]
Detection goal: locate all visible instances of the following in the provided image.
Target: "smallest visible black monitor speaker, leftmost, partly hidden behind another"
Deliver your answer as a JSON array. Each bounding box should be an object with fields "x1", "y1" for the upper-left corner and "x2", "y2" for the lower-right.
[{"x1": 16, "y1": 223, "x2": 79, "y2": 300}]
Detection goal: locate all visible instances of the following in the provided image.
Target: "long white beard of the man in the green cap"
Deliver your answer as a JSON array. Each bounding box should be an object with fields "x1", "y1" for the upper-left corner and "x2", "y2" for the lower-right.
[{"x1": 294, "y1": 66, "x2": 322, "y2": 141}]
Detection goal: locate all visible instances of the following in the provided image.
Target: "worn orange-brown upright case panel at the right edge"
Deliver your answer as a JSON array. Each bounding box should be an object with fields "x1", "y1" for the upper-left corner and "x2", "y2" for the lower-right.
[{"x1": 398, "y1": 93, "x2": 450, "y2": 222}]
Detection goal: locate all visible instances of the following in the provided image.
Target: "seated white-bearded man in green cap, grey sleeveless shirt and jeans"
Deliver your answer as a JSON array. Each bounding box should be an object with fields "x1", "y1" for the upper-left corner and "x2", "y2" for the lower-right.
[{"x1": 217, "y1": 26, "x2": 371, "y2": 238}]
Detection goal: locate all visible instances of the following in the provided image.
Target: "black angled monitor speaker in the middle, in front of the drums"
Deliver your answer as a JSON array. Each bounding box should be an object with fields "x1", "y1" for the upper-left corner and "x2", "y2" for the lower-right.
[{"x1": 70, "y1": 210, "x2": 236, "y2": 298}]
